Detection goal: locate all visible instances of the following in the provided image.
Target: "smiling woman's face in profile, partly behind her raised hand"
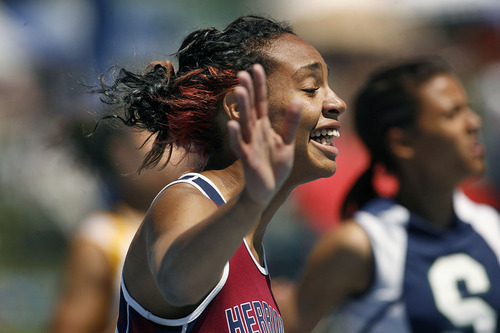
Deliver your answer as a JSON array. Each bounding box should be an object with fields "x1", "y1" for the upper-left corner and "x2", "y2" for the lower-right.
[{"x1": 268, "y1": 34, "x2": 346, "y2": 183}]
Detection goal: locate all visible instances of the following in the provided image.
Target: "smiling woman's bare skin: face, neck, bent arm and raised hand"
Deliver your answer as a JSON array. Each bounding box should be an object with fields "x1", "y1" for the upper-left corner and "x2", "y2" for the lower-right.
[{"x1": 123, "y1": 34, "x2": 345, "y2": 318}]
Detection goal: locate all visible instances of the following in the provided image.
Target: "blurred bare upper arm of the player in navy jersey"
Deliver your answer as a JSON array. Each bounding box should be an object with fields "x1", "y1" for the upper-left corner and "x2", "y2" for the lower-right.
[{"x1": 297, "y1": 220, "x2": 373, "y2": 330}]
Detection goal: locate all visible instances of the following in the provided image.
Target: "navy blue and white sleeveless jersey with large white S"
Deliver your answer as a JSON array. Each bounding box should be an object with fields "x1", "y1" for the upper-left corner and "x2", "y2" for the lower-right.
[{"x1": 342, "y1": 192, "x2": 500, "y2": 333}]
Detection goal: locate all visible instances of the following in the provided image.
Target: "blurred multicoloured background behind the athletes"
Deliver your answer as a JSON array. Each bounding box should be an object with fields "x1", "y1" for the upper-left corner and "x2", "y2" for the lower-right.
[{"x1": 0, "y1": 0, "x2": 500, "y2": 333}]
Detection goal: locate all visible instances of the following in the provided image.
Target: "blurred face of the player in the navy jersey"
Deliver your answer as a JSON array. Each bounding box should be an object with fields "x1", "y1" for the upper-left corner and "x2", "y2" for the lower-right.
[{"x1": 413, "y1": 74, "x2": 485, "y2": 182}]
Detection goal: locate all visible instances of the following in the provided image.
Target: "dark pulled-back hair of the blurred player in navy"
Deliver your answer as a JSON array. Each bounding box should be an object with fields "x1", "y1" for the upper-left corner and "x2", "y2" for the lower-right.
[{"x1": 342, "y1": 57, "x2": 453, "y2": 218}]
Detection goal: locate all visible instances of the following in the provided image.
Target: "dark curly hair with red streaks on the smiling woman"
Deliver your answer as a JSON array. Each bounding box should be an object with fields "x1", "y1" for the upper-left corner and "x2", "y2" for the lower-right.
[{"x1": 93, "y1": 15, "x2": 294, "y2": 169}]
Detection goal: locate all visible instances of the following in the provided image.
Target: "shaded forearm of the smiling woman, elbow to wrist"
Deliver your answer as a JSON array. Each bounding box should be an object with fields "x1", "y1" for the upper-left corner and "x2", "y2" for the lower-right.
[{"x1": 156, "y1": 191, "x2": 265, "y2": 306}]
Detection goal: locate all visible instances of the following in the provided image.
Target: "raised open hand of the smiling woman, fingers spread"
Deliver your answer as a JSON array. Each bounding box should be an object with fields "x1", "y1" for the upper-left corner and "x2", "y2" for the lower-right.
[{"x1": 228, "y1": 65, "x2": 302, "y2": 204}]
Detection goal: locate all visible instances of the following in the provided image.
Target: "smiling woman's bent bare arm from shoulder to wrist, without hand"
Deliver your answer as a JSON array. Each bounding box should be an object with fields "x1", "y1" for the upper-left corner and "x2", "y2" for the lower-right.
[{"x1": 124, "y1": 179, "x2": 261, "y2": 311}]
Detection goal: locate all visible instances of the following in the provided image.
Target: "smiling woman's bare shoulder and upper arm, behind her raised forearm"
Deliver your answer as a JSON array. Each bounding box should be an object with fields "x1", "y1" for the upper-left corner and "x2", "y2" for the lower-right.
[{"x1": 123, "y1": 183, "x2": 223, "y2": 317}]
